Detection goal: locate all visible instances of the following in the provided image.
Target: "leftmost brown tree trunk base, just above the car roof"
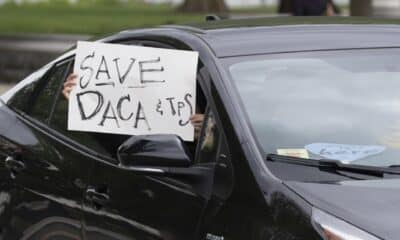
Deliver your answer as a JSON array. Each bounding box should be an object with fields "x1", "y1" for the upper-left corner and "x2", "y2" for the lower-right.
[{"x1": 179, "y1": 0, "x2": 228, "y2": 13}]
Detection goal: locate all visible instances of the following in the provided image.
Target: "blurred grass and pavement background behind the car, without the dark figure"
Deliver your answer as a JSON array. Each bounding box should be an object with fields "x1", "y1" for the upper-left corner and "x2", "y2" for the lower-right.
[{"x1": 0, "y1": 0, "x2": 394, "y2": 87}]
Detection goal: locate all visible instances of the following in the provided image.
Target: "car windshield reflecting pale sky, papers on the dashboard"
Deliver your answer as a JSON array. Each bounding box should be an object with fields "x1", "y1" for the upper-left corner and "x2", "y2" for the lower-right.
[{"x1": 223, "y1": 48, "x2": 400, "y2": 167}]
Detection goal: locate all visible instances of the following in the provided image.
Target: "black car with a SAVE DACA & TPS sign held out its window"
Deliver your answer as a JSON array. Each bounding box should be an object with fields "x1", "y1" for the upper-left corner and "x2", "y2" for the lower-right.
[{"x1": 0, "y1": 18, "x2": 400, "y2": 240}]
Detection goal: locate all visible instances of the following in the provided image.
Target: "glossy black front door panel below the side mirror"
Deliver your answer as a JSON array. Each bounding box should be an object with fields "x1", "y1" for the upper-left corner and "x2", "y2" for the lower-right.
[{"x1": 84, "y1": 159, "x2": 211, "y2": 240}]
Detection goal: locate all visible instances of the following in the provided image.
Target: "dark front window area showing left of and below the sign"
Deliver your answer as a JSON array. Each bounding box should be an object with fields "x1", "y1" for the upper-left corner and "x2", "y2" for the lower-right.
[{"x1": 50, "y1": 64, "x2": 129, "y2": 157}]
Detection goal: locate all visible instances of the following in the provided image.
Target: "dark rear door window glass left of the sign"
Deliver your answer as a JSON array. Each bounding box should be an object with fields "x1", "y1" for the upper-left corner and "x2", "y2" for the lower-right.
[{"x1": 29, "y1": 62, "x2": 69, "y2": 122}]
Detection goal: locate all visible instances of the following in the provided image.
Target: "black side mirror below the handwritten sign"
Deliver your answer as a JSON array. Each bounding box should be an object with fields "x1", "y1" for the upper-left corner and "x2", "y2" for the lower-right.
[{"x1": 117, "y1": 135, "x2": 192, "y2": 167}]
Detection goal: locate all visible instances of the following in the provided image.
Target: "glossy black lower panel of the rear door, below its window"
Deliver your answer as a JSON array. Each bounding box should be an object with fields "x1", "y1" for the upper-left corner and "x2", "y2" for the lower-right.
[{"x1": 0, "y1": 102, "x2": 91, "y2": 239}]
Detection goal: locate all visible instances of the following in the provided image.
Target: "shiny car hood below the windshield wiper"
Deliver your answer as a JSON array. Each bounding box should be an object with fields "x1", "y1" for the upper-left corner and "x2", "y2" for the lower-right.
[{"x1": 286, "y1": 179, "x2": 400, "y2": 240}]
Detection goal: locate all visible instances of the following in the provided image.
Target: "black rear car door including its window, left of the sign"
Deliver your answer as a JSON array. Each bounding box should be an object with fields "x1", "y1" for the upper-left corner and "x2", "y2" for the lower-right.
[{"x1": 0, "y1": 60, "x2": 92, "y2": 240}]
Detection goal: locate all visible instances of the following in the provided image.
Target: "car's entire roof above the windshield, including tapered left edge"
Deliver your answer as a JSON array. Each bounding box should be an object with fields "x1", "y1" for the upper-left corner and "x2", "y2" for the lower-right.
[{"x1": 164, "y1": 17, "x2": 400, "y2": 58}]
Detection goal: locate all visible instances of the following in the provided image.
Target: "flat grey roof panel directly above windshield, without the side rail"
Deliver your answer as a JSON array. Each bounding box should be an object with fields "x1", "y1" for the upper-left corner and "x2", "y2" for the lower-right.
[{"x1": 202, "y1": 25, "x2": 400, "y2": 57}]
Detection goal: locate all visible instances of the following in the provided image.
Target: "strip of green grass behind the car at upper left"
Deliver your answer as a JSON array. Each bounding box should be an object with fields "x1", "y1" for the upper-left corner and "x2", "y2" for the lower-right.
[{"x1": 0, "y1": 1, "x2": 203, "y2": 35}]
